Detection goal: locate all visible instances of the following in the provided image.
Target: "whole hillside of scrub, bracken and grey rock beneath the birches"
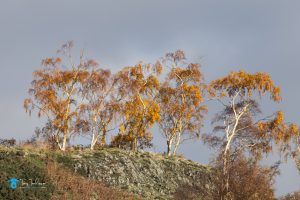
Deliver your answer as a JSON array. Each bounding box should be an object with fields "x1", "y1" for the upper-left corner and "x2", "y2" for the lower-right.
[{"x1": 0, "y1": 147, "x2": 213, "y2": 200}]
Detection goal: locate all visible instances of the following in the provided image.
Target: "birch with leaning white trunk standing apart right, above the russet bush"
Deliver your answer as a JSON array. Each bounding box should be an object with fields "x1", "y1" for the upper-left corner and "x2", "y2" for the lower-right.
[{"x1": 204, "y1": 71, "x2": 298, "y2": 198}]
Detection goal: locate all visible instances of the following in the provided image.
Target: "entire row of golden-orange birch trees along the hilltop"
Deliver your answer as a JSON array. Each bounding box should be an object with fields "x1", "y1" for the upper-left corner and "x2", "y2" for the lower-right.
[{"x1": 24, "y1": 43, "x2": 299, "y2": 167}]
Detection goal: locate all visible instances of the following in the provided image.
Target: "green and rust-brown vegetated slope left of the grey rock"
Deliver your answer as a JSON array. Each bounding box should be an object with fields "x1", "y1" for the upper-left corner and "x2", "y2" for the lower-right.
[{"x1": 0, "y1": 148, "x2": 140, "y2": 200}]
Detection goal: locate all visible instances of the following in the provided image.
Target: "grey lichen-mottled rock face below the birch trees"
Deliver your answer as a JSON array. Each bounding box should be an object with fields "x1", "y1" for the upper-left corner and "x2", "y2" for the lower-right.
[{"x1": 59, "y1": 149, "x2": 213, "y2": 199}]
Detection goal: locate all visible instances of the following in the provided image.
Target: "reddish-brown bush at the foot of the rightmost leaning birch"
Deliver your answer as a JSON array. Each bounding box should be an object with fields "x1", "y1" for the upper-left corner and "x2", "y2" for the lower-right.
[{"x1": 214, "y1": 154, "x2": 279, "y2": 200}]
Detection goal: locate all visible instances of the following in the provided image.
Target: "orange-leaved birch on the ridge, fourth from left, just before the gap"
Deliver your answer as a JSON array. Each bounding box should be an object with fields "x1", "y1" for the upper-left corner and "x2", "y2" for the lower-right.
[{"x1": 156, "y1": 51, "x2": 206, "y2": 155}]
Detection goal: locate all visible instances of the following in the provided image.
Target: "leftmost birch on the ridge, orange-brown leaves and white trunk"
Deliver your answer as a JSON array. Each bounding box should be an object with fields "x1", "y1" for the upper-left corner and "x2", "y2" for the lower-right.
[{"x1": 24, "y1": 43, "x2": 95, "y2": 150}]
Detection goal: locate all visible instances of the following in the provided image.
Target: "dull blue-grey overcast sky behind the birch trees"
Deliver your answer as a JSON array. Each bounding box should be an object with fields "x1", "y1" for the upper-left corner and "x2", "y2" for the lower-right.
[{"x1": 0, "y1": 0, "x2": 300, "y2": 195}]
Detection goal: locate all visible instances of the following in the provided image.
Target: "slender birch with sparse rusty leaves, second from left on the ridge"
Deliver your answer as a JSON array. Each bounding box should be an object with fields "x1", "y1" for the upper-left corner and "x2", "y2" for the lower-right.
[{"x1": 76, "y1": 68, "x2": 119, "y2": 149}]
